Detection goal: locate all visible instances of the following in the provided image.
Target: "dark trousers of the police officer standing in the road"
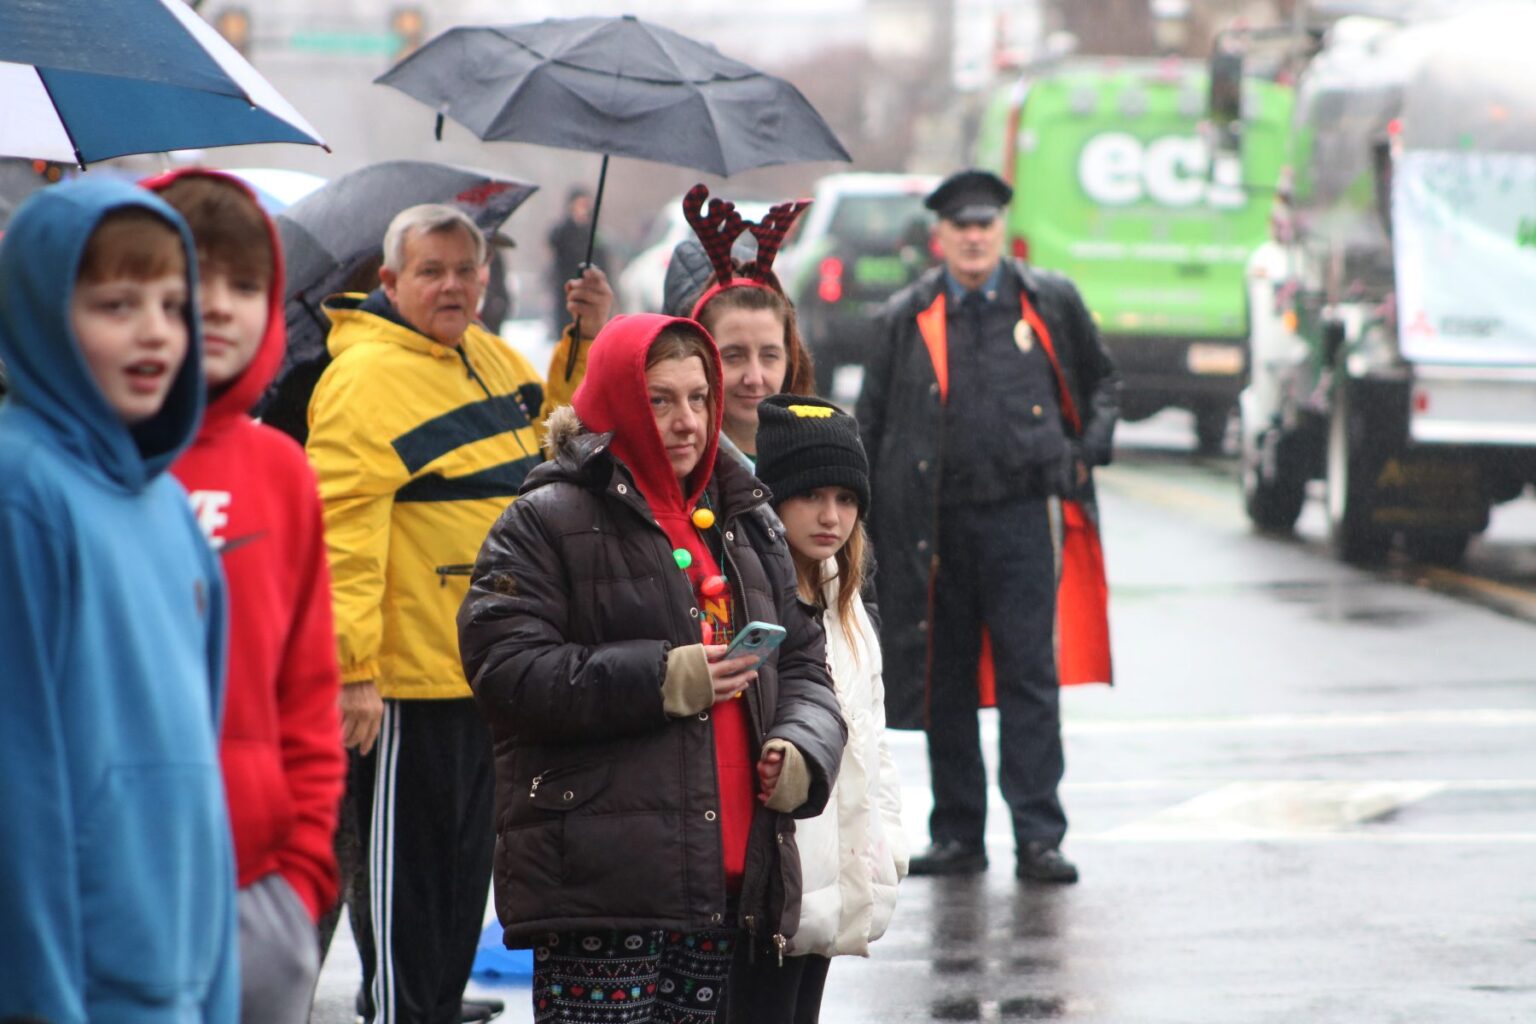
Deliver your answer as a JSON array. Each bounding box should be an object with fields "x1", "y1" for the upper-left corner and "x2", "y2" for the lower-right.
[{"x1": 928, "y1": 499, "x2": 1066, "y2": 844}]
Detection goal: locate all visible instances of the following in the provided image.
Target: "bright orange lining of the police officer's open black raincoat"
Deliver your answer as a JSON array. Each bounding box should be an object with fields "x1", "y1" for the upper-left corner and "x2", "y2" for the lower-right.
[{"x1": 917, "y1": 289, "x2": 1114, "y2": 708}]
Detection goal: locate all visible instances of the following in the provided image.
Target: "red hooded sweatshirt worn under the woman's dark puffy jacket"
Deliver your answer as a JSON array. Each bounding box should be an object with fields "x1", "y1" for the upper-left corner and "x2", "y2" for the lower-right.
[{"x1": 571, "y1": 316, "x2": 757, "y2": 890}]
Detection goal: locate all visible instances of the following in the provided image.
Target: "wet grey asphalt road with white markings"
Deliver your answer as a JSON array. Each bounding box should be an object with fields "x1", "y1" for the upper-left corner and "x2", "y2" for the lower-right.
[{"x1": 313, "y1": 415, "x2": 1536, "y2": 1024}]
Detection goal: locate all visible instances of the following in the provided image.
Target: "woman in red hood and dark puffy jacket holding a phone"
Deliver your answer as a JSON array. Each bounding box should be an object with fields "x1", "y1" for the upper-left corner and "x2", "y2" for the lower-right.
[{"x1": 459, "y1": 315, "x2": 846, "y2": 1024}]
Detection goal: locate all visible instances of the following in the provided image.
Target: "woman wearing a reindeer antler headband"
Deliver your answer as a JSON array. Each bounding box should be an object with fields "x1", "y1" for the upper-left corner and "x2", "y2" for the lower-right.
[{"x1": 664, "y1": 184, "x2": 816, "y2": 465}]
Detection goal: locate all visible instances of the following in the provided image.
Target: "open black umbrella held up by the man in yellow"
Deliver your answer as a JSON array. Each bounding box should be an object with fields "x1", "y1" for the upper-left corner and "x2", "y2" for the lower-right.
[{"x1": 375, "y1": 15, "x2": 852, "y2": 378}]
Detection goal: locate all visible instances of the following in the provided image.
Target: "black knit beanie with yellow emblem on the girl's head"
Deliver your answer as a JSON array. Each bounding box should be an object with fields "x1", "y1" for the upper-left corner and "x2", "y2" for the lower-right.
[{"x1": 757, "y1": 395, "x2": 869, "y2": 513}]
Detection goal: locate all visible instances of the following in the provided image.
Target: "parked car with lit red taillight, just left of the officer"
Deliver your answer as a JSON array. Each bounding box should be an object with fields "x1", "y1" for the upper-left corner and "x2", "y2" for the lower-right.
[{"x1": 779, "y1": 173, "x2": 938, "y2": 395}]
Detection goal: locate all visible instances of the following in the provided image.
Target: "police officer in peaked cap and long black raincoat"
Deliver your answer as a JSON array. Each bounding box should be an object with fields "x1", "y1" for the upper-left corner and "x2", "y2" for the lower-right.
[{"x1": 857, "y1": 170, "x2": 1120, "y2": 883}]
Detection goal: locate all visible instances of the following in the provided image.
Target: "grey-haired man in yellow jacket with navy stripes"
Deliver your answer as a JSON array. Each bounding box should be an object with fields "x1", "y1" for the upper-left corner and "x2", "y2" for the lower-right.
[{"x1": 307, "y1": 206, "x2": 611, "y2": 1024}]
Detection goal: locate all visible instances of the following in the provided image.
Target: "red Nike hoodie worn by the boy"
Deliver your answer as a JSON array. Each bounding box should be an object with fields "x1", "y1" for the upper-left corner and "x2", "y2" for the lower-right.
[{"x1": 143, "y1": 169, "x2": 346, "y2": 920}]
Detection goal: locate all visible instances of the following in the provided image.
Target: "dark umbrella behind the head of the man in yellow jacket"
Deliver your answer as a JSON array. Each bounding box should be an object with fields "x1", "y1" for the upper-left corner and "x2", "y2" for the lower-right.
[{"x1": 276, "y1": 160, "x2": 539, "y2": 372}]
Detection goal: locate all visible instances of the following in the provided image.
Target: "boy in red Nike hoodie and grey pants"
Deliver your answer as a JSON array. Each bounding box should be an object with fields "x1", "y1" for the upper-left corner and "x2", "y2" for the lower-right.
[{"x1": 144, "y1": 169, "x2": 346, "y2": 1024}]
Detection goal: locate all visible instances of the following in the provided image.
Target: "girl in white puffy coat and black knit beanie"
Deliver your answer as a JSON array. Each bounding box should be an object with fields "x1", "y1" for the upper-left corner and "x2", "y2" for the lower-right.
[{"x1": 730, "y1": 395, "x2": 908, "y2": 1024}]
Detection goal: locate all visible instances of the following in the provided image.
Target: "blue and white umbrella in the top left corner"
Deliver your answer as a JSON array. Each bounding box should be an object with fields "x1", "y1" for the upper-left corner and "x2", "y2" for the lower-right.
[{"x1": 0, "y1": 0, "x2": 326, "y2": 166}]
